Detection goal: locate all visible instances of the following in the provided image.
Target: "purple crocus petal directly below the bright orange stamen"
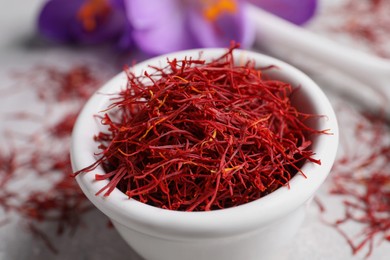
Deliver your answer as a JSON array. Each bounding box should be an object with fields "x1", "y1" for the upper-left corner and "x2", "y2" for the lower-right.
[{"x1": 188, "y1": 5, "x2": 254, "y2": 47}]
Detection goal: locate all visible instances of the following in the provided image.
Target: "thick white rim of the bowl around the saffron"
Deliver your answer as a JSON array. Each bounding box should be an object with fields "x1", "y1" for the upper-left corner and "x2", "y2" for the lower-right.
[{"x1": 70, "y1": 48, "x2": 338, "y2": 238}]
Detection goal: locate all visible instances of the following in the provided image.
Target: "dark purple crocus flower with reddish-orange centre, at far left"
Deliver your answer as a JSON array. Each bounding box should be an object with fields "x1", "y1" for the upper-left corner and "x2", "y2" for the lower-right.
[{"x1": 38, "y1": 0, "x2": 132, "y2": 48}]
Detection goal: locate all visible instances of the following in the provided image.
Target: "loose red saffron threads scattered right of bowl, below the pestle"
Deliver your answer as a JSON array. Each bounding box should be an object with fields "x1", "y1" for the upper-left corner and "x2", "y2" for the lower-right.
[{"x1": 323, "y1": 108, "x2": 390, "y2": 257}]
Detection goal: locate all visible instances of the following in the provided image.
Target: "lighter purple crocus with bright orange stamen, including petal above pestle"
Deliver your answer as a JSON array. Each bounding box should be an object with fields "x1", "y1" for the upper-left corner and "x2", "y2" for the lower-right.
[{"x1": 125, "y1": 0, "x2": 317, "y2": 54}]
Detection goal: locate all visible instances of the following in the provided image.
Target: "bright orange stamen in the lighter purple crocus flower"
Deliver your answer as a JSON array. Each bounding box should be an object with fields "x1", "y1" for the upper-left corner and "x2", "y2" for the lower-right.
[{"x1": 203, "y1": 0, "x2": 237, "y2": 22}]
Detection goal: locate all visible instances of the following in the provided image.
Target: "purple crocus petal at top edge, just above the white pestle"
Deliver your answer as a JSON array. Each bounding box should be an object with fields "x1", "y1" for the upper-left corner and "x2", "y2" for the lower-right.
[{"x1": 248, "y1": 0, "x2": 317, "y2": 25}]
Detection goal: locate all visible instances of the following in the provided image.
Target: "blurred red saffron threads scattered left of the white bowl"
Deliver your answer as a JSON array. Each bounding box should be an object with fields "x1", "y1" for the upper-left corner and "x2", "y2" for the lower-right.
[{"x1": 0, "y1": 63, "x2": 112, "y2": 253}]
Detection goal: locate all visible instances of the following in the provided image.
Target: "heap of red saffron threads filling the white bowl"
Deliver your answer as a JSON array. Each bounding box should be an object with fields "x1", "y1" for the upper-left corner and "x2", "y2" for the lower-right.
[{"x1": 75, "y1": 48, "x2": 326, "y2": 211}]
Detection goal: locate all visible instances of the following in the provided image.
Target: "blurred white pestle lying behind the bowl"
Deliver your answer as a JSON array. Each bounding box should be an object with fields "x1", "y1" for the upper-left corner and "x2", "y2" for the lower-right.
[{"x1": 247, "y1": 5, "x2": 390, "y2": 114}]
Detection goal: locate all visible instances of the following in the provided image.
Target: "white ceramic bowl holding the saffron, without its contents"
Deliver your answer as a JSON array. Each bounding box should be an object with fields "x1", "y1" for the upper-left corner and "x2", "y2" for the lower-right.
[{"x1": 71, "y1": 49, "x2": 338, "y2": 260}]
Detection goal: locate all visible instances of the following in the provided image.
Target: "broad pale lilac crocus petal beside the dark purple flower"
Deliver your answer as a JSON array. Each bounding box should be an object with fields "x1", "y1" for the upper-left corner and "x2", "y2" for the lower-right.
[{"x1": 126, "y1": 0, "x2": 193, "y2": 54}]
